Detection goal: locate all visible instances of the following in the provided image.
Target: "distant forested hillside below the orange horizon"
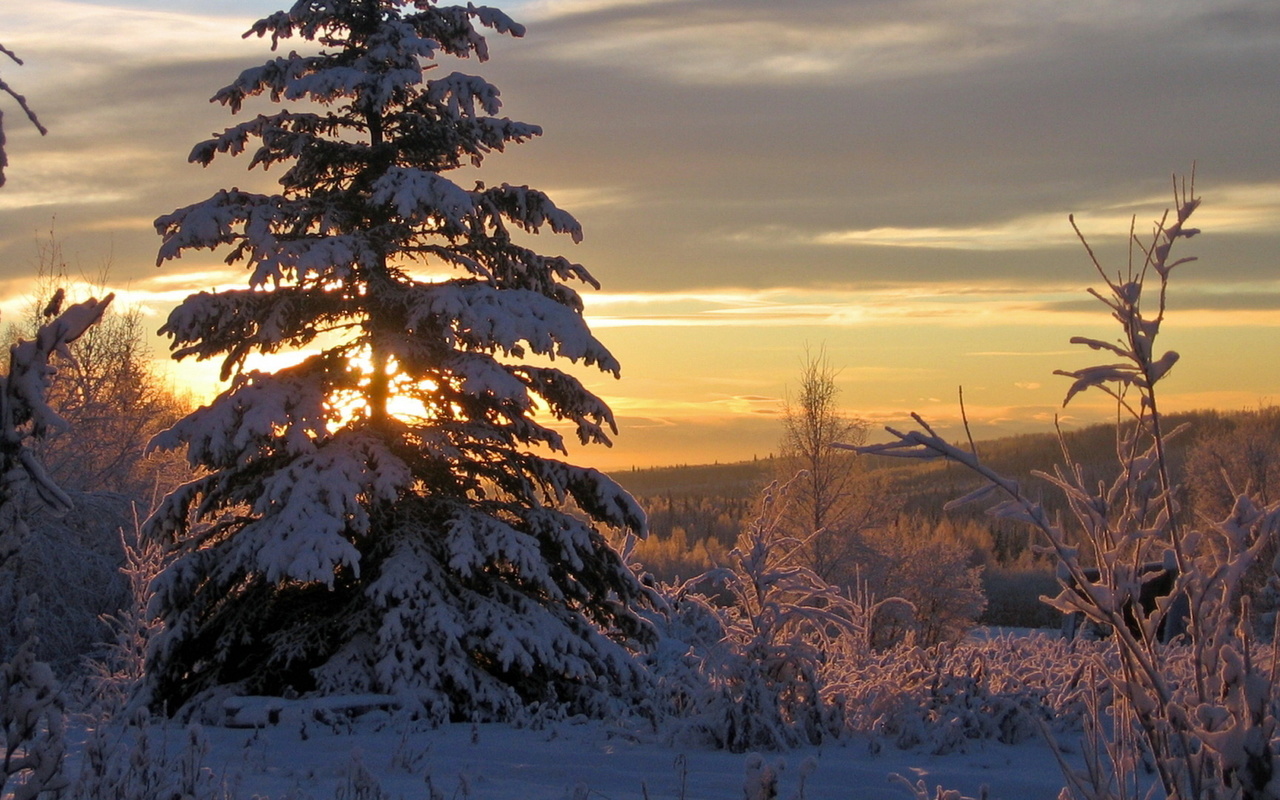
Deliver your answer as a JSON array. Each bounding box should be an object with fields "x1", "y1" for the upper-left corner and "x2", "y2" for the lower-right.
[{"x1": 614, "y1": 407, "x2": 1280, "y2": 626}]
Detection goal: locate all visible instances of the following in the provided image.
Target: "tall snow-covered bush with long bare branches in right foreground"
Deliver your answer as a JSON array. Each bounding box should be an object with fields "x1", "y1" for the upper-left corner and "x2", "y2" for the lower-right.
[{"x1": 858, "y1": 176, "x2": 1280, "y2": 799}]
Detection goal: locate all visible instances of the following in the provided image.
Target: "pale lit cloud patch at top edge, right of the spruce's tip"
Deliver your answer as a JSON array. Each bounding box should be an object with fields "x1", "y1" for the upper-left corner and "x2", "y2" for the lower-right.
[{"x1": 514, "y1": 0, "x2": 1129, "y2": 87}]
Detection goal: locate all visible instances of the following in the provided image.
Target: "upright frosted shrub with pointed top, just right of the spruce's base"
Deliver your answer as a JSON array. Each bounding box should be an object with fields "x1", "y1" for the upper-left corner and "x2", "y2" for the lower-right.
[{"x1": 659, "y1": 485, "x2": 865, "y2": 753}]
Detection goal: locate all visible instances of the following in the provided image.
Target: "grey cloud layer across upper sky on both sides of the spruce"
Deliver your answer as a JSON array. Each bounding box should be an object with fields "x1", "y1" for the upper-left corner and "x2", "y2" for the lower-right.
[{"x1": 0, "y1": 0, "x2": 1280, "y2": 296}]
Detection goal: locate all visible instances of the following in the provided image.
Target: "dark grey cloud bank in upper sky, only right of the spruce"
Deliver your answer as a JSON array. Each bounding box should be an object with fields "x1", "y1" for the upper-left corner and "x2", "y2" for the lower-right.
[{"x1": 473, "y1": 0, "x2": 1280, "y2": 285}]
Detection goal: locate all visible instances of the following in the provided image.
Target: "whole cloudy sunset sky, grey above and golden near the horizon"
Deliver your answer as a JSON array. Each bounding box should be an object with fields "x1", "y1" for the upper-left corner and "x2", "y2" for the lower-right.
[{"x1": 0, "y1": 0, "x2": 1280, "y2": 468}]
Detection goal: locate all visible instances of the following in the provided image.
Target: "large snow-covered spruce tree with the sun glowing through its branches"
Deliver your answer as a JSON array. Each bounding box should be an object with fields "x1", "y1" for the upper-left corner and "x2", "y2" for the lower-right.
[{"x1": 145, "y1": 0, "x2": 650, "y2": 719}]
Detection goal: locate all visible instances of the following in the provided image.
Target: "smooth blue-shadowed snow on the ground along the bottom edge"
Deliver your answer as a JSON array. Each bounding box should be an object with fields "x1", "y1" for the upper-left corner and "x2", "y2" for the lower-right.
[{"x1": 73, "y1": 719, "x2": 1080, "y2": 800}]
